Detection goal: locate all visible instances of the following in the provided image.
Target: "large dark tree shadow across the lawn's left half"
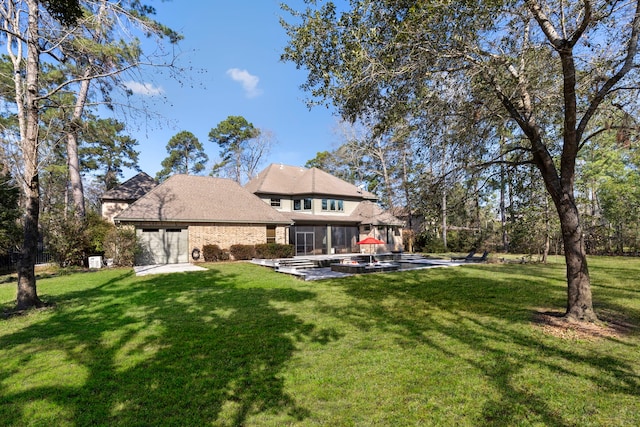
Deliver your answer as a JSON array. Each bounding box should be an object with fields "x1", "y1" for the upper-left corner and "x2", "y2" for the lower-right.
[{"x1": 0, "y1": 270, "x2": 337, "y2": 426}]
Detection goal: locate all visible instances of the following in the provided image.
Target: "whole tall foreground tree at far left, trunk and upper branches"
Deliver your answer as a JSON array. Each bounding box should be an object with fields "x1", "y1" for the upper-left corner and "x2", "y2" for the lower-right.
[{"x1": 0, "y1": 0, "x2": 178, "y2": 310}]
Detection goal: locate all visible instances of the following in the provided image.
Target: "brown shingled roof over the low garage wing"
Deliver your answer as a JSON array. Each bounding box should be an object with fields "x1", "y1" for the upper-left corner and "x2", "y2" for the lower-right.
[{"x1": 115, "y1": 175, "x2": 291, "y2": 224}]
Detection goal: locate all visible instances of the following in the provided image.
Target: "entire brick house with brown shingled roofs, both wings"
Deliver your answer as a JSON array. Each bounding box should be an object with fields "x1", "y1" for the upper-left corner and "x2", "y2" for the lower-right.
[{"x1": 108, "y1": 164, "x2": 403, "y2": 264}]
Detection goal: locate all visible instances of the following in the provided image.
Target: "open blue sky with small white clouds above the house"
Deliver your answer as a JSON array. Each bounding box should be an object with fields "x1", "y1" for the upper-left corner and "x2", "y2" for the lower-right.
[{"x1": 118, "y1": 0, "x2": 339, "y2": 179}]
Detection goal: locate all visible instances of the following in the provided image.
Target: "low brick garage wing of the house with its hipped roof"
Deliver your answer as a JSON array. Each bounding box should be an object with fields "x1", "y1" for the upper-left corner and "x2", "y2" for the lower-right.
[{"x1": 114, "y1": 175, "x2": 291, "y2": 264}]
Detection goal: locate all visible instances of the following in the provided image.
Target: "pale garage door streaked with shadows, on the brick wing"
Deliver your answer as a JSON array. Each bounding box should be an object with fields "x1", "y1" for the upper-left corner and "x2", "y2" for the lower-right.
[{"x1": 136, "y1": 228, "x2": 189, "y2": 265}]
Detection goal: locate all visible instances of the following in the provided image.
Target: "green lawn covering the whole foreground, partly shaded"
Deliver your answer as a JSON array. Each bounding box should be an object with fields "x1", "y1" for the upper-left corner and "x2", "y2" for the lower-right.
[{"x1": 0, "y1": 258, "x2": 640, "y2": 426}]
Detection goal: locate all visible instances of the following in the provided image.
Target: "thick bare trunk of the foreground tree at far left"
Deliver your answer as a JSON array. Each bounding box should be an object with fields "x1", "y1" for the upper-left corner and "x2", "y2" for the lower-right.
[{"x1": 16, "y1": 0, "x2": 42, "y2": 310}]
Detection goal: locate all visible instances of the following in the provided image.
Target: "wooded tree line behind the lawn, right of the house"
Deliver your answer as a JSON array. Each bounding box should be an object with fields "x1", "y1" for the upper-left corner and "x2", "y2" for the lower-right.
[{"x1": 306, "y1": 117, "x2": 640, "y2": 262}]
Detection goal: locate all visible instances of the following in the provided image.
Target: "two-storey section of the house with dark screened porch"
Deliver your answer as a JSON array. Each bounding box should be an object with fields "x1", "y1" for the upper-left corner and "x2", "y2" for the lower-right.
[{"x1": 245, "y1": 164, "x2": 403, "y2": 255}]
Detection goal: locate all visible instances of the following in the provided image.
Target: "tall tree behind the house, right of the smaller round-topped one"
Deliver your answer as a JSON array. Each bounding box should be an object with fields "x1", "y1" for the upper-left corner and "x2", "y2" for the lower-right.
[{"x1": 209, "y1": 116, "x2": 267, "y2": 184}]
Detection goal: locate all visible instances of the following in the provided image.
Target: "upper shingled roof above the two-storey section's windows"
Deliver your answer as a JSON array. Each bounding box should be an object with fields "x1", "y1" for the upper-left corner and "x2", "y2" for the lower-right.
[{"x1": 245, "y1": 163, "x2": 377, "y2": 200}]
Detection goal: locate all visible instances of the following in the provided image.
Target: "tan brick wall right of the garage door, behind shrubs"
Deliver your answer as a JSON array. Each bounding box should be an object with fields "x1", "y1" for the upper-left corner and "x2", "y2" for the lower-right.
[{"x1": 189, "y1": 224, "x2": 287, "y2": 262}]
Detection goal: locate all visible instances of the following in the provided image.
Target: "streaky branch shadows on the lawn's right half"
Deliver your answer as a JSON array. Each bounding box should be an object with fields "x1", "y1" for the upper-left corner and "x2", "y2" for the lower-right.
[{"x1": 325, "y1": 267, "x2": 640, "y2": 426}]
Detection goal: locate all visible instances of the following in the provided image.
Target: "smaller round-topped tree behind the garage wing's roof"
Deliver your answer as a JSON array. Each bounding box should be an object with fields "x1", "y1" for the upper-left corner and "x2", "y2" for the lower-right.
[{"x1": 156, "y1": 130, "x2": 209, "y2": 181}]
